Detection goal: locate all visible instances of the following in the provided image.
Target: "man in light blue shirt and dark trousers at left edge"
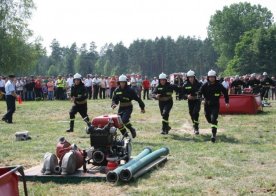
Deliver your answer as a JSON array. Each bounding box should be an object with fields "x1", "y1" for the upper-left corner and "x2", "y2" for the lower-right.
[{"x1": 2, "y1": 75, "x2": 17, "y2": 123}]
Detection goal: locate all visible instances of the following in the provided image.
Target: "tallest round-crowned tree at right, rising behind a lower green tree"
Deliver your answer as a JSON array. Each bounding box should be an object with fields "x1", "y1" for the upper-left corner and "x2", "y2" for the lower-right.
[{"x1": 208, "y1": 2, "x2": 273, "y2": 69}]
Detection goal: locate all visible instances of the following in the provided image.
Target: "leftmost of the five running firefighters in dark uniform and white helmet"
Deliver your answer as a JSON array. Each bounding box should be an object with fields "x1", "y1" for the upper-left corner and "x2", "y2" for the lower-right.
[{"x1": 66, "y1": 73, "x2": 91, "y2": 132}]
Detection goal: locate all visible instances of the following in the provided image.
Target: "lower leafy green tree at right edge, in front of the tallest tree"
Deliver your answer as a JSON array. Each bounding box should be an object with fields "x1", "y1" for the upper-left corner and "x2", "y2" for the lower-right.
[{"x1": 227, "y1": 25, "x2": 276, "y2": 74}]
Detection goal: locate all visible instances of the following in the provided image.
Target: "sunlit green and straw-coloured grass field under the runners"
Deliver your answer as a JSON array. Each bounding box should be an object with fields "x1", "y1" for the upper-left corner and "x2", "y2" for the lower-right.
[{"x1": 0, "y1": 100, "x2": 276, "y2": 195}]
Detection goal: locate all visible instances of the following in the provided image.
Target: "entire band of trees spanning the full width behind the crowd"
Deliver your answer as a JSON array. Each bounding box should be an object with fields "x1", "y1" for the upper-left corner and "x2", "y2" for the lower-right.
[{"x1": 0, "y1": 0, "x2": 276, "y2": 76}]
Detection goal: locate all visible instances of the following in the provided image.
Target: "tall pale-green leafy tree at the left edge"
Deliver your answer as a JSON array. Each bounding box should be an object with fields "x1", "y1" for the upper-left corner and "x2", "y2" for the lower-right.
[{"x1": 0, "y1": 0, "x2": 42, "y2": 74}]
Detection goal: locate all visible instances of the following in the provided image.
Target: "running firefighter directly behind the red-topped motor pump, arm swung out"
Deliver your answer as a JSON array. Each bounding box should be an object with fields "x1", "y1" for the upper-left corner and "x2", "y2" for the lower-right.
[{"x1": 111, "y1": 75, "x2": 145, "y2": 138}]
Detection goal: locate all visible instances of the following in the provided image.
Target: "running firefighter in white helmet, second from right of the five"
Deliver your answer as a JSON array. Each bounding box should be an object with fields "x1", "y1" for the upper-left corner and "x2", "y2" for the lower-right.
[{"x1": 183, "y1": 70, "x2": 202, "y2": 135}]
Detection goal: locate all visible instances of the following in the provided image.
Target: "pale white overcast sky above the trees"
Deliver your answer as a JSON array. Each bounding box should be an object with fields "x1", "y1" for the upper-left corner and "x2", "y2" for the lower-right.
[{"x1": 29, "y1": 0, "x2": 276, "y2": 52}]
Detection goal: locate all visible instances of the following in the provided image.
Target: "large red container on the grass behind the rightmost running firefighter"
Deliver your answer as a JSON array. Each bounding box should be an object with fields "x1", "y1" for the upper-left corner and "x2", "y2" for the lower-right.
[{"x1": 219, "y1": 95, "x2": 263, "y2": 114}]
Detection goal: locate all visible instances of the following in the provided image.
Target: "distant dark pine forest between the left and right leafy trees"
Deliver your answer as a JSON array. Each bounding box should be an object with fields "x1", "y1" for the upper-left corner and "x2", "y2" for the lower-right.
[{"x1": 35, "y1": 37, "x2": 217, "y2": 76}]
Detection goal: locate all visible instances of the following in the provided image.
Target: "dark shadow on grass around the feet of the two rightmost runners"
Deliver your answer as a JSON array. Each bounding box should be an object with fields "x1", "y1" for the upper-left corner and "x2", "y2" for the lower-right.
[{"x1": 170, "y1": 134, "x2": 240, "y2": 144}]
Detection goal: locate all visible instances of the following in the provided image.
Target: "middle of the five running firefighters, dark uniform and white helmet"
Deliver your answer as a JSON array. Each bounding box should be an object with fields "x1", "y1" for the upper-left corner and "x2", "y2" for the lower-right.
[{"x1": 152, "y1": 73, "x2": 179, "y2": 135}]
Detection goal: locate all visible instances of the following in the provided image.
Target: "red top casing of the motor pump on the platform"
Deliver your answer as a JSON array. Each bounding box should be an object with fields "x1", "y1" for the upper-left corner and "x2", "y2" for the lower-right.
[{"x1": 92, "y1": 114, "x2": 123, "y2": 128}]
